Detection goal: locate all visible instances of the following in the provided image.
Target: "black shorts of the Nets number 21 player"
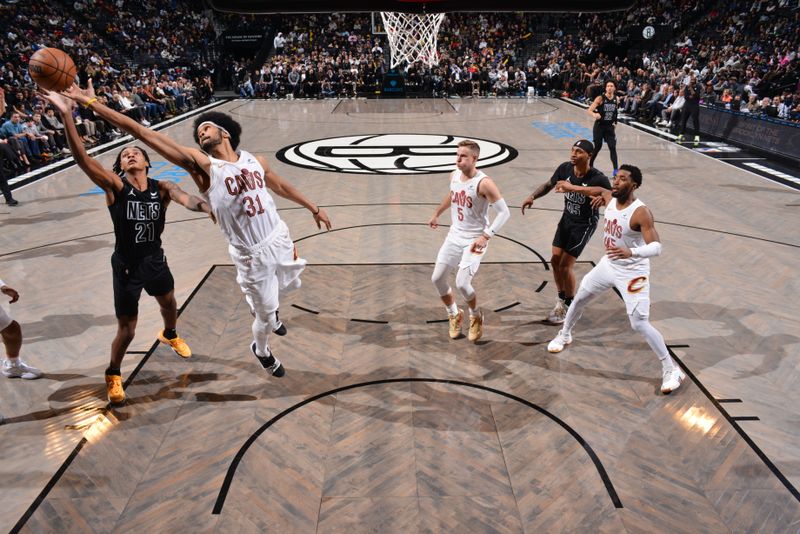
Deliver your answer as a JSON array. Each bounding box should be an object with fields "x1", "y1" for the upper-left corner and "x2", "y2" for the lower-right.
[{"x1": 111, "y1": 251, "x2": 175, "y2": 317}]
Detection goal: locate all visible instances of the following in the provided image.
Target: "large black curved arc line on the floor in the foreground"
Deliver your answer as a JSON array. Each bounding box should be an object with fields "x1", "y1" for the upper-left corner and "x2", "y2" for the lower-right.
[{"x1": 211, "y1": 378, "x2": 622, "y2": 515}]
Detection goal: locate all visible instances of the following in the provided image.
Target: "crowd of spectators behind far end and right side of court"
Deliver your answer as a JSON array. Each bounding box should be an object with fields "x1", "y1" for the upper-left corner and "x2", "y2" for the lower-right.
[{"x1": 220, "y1": 0, "x2": 800, "y2": 126}]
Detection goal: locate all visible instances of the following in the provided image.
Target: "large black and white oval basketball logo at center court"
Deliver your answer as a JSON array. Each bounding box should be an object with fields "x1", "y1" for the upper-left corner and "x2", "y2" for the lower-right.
[{"x1": 276, "y1": 134, "x2": 517, "y2": 174}]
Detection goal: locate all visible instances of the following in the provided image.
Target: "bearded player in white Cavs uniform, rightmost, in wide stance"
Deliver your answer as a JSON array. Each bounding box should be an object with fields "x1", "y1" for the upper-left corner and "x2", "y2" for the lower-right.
[{"x1": 547, "y1": 165, "x2": 686, "y2": 394}]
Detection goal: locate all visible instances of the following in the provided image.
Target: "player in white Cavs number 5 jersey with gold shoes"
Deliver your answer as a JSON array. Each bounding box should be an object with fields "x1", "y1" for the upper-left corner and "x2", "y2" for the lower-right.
[{"x1": 428, "y1": 139, "x2": 511, "y2": 342}]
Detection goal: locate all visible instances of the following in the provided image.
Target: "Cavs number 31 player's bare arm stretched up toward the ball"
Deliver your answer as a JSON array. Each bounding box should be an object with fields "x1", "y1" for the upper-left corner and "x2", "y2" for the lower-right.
[{"x1": 63, "y1": 80, "x2": 211, "y2": 184}]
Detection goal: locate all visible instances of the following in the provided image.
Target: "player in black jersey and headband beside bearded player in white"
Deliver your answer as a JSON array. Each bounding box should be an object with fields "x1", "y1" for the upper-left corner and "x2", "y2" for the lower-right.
[{"x1": 522, "y1": 139, "x2": 611, "y2": 324}]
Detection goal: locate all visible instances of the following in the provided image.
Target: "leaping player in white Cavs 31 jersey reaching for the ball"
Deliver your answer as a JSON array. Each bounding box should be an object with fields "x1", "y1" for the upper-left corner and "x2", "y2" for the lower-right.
[{"x1": 64, "y1": 84, "x2": 331, "y2": 377}]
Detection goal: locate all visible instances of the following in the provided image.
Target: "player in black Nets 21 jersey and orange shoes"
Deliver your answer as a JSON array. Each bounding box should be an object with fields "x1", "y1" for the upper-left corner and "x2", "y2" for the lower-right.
[{"x1": 41, "y1": 91, "x2": 211, "y2": 404}]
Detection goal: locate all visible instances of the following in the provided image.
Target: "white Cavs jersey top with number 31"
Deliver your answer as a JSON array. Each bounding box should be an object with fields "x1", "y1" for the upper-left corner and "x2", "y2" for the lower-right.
[{"x1": 203, "y1": 150, "x2": 282, "y2": 249}]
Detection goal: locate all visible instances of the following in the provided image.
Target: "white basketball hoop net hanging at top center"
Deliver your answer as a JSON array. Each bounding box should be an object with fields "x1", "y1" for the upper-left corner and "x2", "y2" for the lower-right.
[{"x1": 381, "y1": 11, "x2": 444, "y2": 68}]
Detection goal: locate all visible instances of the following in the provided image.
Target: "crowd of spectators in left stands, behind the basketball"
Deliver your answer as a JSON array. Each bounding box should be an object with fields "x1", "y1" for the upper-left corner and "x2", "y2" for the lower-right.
[{"x1": 0, "y1": 0, "x2": 216, "y2": 180}]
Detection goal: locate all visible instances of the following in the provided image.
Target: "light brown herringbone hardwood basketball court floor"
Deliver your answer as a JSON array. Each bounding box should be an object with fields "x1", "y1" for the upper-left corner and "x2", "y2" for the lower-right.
[{"x1": 0, "y1": 100, "x2": 800, "y2": 532}]
